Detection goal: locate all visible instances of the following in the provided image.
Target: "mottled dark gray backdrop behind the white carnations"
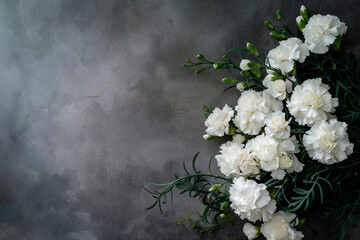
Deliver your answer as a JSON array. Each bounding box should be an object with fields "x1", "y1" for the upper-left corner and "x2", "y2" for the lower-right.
[{"x1": 0, "y1": 0, "x2": 360, "y2": 240}]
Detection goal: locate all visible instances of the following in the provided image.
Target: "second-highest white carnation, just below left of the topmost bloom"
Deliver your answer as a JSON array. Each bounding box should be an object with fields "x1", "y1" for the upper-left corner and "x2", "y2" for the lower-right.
[{"x1": 267, "y1": 38, "x2": 309, "y2": 74}]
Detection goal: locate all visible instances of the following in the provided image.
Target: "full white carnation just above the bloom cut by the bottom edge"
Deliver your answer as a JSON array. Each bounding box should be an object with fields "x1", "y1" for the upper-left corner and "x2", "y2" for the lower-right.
[{"x1": 229, "y1": 177, "x2": 276, "y2": 222}]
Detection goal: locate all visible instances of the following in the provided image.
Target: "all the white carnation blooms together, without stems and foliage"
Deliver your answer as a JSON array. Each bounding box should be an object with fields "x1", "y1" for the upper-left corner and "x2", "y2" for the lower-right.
[{"x1": 201, "y1": 6, "x2": 354, "y2": 240}]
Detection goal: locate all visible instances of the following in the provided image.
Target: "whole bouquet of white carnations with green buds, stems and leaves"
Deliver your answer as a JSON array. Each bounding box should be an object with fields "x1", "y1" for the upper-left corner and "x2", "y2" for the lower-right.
[{"x1": 148, "y1": 6, "x2": 360, "y2": 240}]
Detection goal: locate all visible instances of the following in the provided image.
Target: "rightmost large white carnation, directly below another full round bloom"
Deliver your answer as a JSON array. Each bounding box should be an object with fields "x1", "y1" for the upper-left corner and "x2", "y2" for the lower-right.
[{"x1": 303, "y1": 119, "x2": 354, "y2": 164}]
